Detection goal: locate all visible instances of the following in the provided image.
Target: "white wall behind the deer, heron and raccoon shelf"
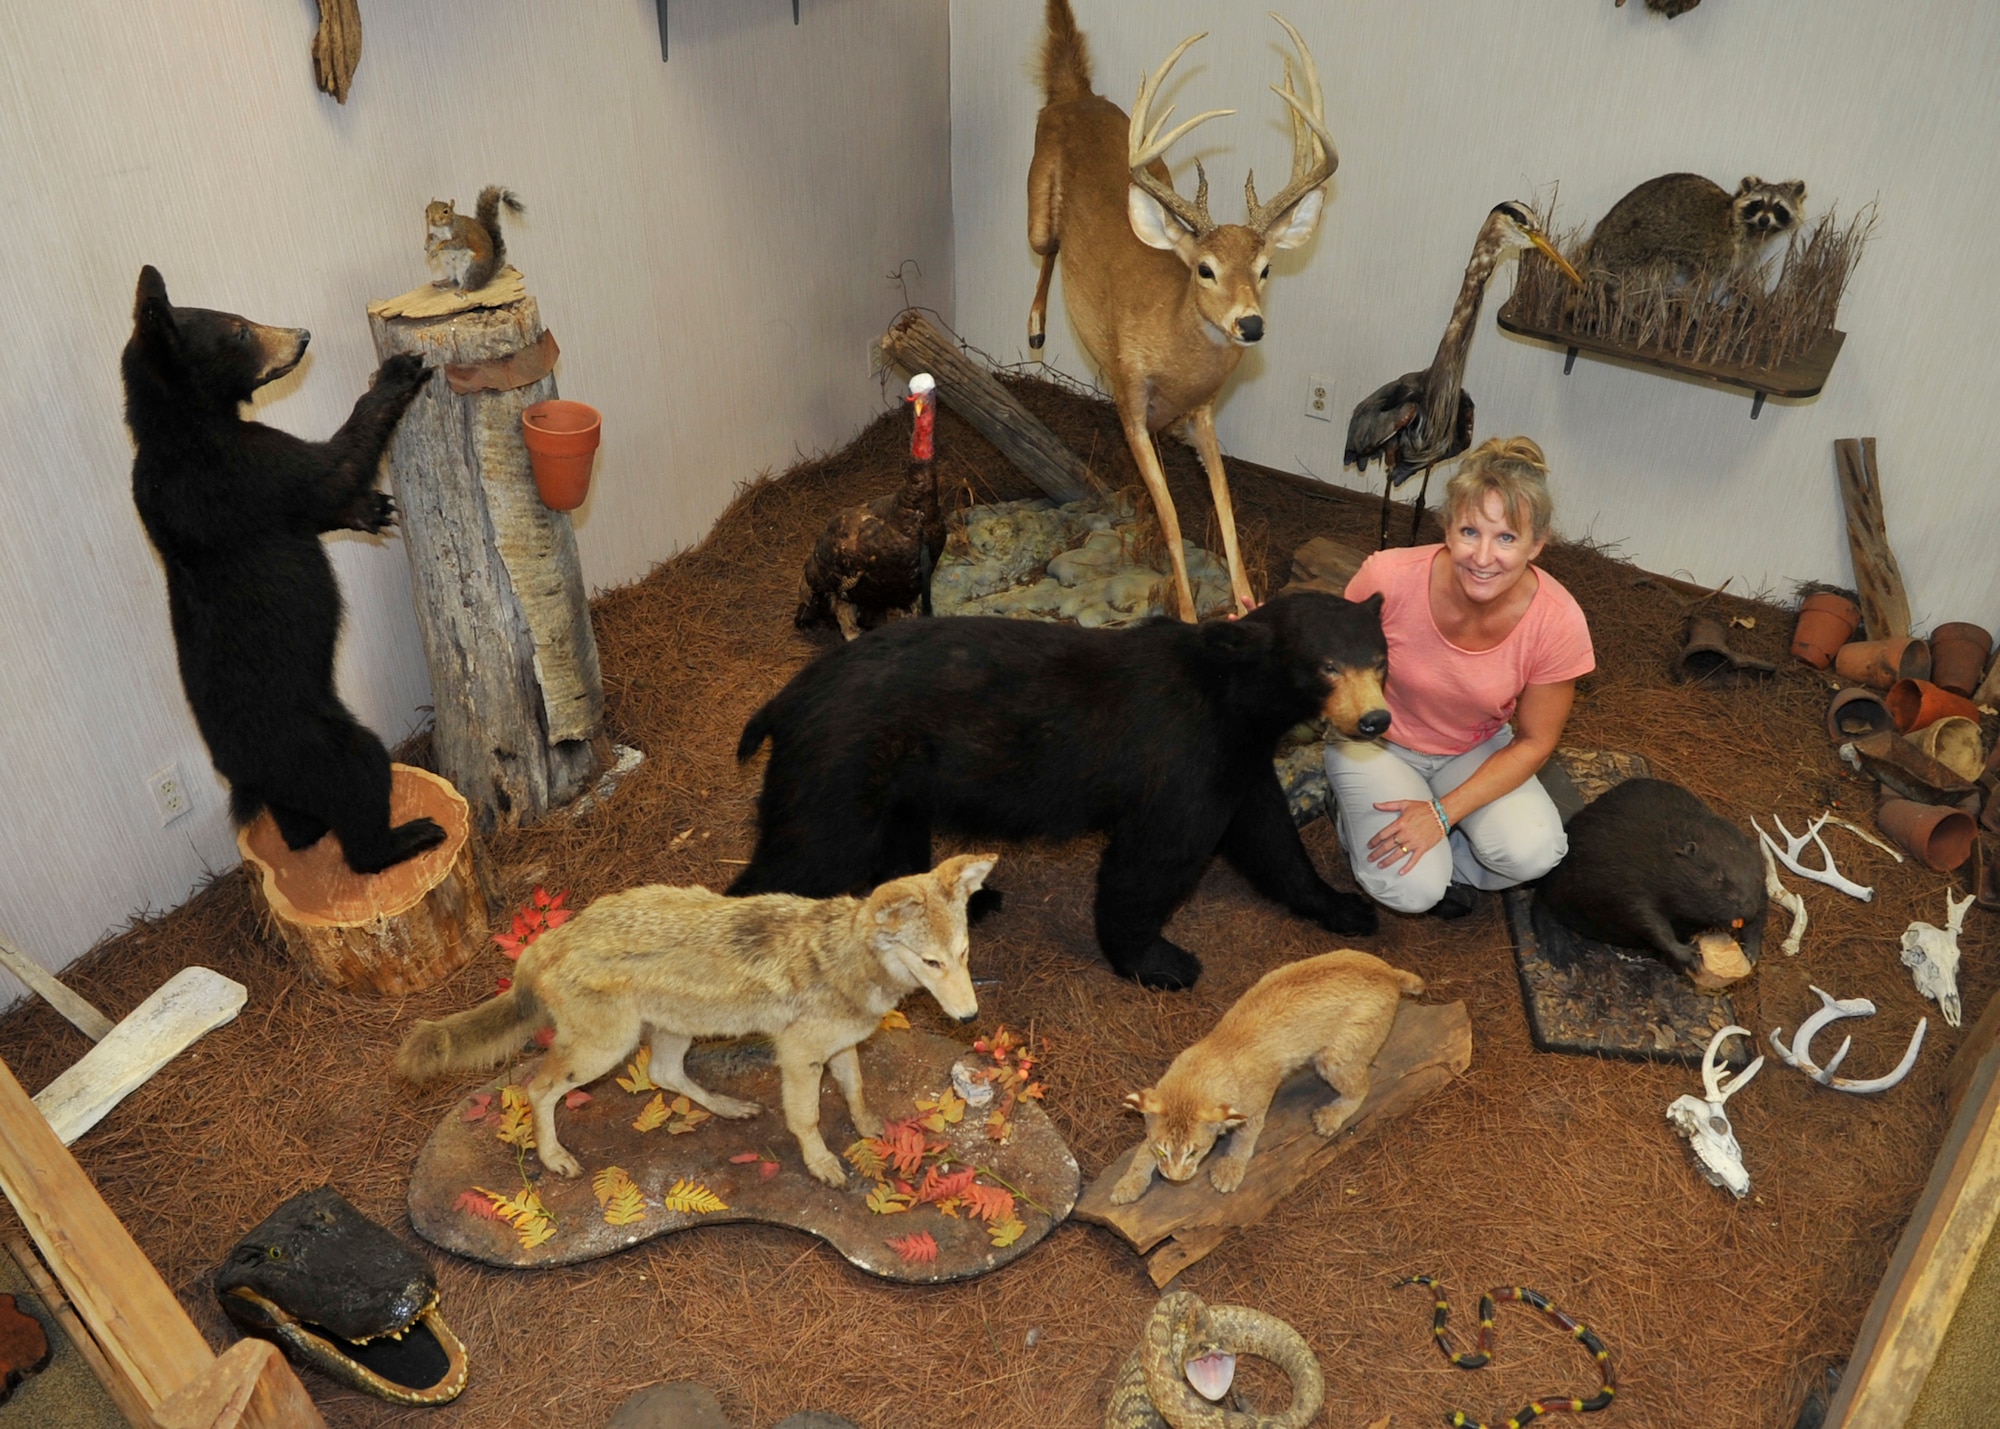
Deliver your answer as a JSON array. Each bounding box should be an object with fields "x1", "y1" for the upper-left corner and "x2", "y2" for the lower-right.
[{"x1": 952, "y1": 0, "x2": 2000, "y2": 628}]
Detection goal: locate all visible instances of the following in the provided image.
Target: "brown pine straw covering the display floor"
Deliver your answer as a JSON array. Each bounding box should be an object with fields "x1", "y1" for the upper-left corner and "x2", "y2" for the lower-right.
[{"x1": 0, "y1": 384, "x2": 1996, "y2": 1429}]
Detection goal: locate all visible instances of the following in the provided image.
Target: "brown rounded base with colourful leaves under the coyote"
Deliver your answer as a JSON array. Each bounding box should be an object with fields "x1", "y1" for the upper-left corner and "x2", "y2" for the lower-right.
[{"x1": 410, "y1": 1031, "x2": 1082, "y2": 1285}]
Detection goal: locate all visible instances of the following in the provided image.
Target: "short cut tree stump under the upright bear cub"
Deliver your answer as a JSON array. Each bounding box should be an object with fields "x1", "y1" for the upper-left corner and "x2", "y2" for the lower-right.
[{"x1": 236, "y1": 765, "x2": 486, "y2": 997}]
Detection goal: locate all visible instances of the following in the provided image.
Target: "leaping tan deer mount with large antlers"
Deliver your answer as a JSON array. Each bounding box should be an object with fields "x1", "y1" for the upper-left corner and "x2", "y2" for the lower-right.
[{"x1": 1028, "y1": 0, "x2": 1340, "y2": 620}]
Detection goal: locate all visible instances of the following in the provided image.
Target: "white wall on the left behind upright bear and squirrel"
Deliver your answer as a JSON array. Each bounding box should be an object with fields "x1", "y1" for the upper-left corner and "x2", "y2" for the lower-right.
[{"x1": 0, "y1": 0, "x2": 952, "y2": 980}]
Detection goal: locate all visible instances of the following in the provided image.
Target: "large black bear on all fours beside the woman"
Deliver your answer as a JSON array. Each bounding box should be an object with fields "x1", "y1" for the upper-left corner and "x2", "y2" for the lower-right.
[{"x1": 730, "y1": 594, "x2": 1388, "y2": 989}]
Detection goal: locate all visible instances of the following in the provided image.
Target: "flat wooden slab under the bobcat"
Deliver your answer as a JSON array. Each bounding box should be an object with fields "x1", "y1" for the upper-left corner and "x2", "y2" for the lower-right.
[{"x1": 1076, "y1": 1003, "x2": 1472, "y2": 1285}]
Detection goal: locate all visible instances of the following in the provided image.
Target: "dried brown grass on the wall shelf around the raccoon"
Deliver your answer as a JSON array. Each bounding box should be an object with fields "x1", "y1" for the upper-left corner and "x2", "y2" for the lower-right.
[{"x1": 1508, "y1": 198, "x2": 1876, "y2": 370}]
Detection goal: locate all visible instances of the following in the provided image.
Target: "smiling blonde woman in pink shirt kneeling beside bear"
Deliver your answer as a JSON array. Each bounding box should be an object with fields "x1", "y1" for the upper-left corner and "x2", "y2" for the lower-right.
[{"x1": 1326, "y1": 436, "x2": 1596, "y2": 917}]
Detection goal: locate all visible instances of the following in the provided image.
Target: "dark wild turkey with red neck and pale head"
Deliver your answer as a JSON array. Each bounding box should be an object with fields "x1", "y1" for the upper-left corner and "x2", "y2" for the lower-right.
[{"x1": 792, "y1": 372, "x2": 944, "y2": 640}]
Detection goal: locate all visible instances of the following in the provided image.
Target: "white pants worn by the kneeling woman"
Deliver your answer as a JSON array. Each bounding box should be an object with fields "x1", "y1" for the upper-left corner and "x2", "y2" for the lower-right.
[{"x1": 1326, "y1": 725, "x2": 1570, "y2": 913}]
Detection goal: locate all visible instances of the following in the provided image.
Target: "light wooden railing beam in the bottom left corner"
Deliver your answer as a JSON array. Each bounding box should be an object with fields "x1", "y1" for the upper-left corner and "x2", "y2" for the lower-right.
[{"x1": 0, "y1": 1063, "x2": 326, "y2": 1429}]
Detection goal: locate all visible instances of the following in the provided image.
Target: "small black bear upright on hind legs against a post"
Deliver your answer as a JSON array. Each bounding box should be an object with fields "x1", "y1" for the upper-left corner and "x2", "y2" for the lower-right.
[{"x1": 124, "y1": 266, "x2": 444, "y2": 873}]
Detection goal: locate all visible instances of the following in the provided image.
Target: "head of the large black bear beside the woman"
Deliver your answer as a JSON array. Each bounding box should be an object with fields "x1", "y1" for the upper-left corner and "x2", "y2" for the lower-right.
[{"x1": 1204, "y1": 590, "x2": 1388, "y2": 739}]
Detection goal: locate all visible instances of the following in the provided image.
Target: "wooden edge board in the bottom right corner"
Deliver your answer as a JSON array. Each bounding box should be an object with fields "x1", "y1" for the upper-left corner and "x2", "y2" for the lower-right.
[{"x1": 1826, "y1": 1049, "x2": 2000, "y2": 1429}]
